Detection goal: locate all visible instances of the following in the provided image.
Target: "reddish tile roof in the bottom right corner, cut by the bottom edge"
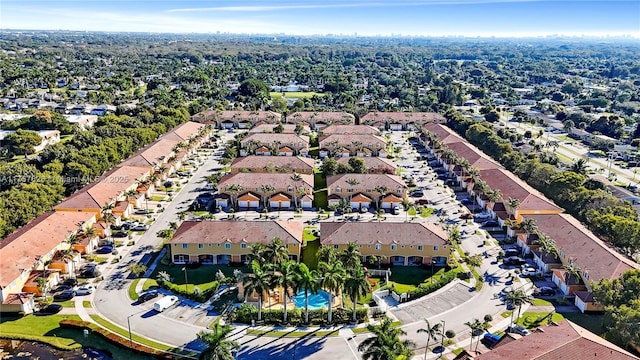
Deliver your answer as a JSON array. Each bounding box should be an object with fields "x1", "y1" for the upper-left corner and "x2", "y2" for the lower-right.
[{"x1": 475, "y1": 320, "x2": 638, "y2": 360}]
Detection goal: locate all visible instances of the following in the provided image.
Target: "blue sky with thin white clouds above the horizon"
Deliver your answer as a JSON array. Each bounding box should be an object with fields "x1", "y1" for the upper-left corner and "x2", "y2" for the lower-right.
[{"x1": 0, "y1": 0, "x2": 640, "y2": 37}]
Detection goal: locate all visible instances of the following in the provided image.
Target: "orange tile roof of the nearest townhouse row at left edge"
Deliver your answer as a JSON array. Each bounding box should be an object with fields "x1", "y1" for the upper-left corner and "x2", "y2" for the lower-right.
[{"x1": 0, "y1": 211, "x2": 96, "y2": 287}]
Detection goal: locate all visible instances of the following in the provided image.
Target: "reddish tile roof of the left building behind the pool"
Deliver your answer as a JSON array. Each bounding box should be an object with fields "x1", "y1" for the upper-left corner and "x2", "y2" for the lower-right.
[{"x1": 169, "y1": 221, "x2": 304, "y2": 244}]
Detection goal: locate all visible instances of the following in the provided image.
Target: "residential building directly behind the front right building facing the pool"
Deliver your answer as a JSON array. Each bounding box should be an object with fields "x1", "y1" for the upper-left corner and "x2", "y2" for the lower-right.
[{"x1": 327, "y1": 174, "x2": 407, "y2": 209}]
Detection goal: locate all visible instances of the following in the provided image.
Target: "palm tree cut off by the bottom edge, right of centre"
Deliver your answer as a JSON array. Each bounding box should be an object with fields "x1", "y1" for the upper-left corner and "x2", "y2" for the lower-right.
[{"x1": 358, "y1": 318, "x2": 415, "y2": 360}]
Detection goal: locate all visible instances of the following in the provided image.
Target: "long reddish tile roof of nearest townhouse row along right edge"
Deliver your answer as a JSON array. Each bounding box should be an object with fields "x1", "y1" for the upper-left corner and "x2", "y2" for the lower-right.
[{"x1": 523, "y1": 214, "x2": 640, "y2": 282}]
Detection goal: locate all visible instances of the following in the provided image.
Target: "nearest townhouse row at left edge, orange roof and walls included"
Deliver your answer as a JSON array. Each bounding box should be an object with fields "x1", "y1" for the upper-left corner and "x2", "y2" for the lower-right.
[{"x1": 0, "y1": 211, "x2": 97, "y2": 311}]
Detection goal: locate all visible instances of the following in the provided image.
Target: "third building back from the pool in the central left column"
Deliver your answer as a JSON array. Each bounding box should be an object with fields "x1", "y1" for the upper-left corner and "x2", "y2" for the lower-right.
[{"x1": 231, "y1": 155, "x2": 315, "y2": 175}]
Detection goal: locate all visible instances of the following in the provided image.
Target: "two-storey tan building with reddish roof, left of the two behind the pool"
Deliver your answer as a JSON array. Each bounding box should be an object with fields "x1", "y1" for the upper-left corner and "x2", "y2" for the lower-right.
[{"x1": 169, "y1": 221, "x2": 304, "y2": 264}]
